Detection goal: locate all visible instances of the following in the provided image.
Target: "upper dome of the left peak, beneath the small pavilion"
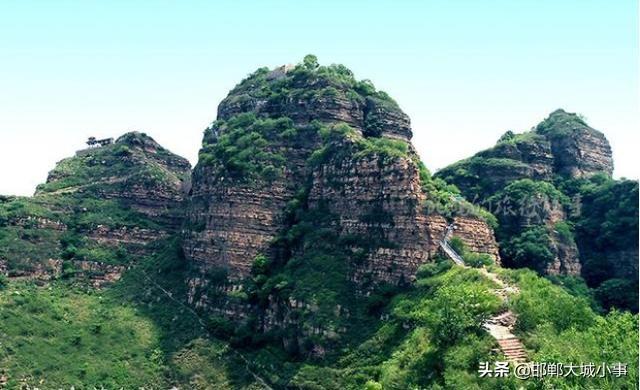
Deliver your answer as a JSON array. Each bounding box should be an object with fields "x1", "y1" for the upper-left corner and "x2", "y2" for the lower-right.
[{"x1": 36, "y1": 132, "x2": 191, "y2": 229}]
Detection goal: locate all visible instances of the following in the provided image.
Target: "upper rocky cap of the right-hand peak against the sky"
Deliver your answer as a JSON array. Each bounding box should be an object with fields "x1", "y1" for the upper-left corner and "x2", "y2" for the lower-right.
[{"x1": 436, "y1": 110, "x2": 613, "y2": 200}]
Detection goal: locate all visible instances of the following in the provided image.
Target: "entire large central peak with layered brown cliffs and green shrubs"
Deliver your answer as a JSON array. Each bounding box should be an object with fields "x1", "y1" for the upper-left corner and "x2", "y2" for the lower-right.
[{"x1": 183, "y1": 58, "x2": 499, "y2": 347}]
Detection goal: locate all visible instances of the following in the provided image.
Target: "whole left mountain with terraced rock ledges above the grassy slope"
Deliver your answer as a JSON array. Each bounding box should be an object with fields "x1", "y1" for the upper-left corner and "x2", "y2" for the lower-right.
[{"x1": 0, "y1": 132, "x2": 190, "y2": 286}]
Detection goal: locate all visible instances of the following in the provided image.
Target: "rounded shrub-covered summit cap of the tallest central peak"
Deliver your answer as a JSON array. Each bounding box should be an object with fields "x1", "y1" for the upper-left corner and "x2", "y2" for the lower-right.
[{"x1": 218, "y1": 55, "x2": 412, "y2": 140}]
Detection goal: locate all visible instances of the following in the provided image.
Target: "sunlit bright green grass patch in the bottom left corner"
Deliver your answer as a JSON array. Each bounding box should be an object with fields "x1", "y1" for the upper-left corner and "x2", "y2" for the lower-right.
[{"x1": 0, "y1": 283, "x2": 163, "y2": 388}]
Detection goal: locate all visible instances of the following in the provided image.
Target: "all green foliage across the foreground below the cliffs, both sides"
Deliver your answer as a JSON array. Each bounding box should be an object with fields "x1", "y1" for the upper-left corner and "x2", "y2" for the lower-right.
[{"x1": 0, "y1": 241, "x2": 638, "y2": 390}]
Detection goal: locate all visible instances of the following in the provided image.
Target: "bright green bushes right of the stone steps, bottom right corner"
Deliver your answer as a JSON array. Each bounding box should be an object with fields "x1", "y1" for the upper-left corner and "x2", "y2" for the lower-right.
[{"x1": 498, "y1": 269, "x2": 638, "y2": 390}]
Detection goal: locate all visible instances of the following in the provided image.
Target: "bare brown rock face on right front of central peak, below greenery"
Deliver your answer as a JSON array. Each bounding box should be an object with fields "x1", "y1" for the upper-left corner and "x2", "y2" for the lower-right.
[{"x1": 309, "y1": 146, "x2": 499, "y2": 284}]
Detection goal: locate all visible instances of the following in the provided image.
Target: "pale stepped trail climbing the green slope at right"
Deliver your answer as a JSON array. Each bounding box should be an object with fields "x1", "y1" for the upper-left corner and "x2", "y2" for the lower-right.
[{"x1": 440, "y1": 224, "x2": 527, "y2": 363}]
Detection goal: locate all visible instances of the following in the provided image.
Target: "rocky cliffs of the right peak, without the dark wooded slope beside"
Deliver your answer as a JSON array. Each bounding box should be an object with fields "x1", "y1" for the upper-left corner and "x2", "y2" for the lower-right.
[{"x1": 436, "y1": 110, "x2": 613, "y2": 275}]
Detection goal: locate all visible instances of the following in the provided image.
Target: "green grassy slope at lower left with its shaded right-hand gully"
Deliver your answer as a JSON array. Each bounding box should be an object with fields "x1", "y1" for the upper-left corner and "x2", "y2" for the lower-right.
[{"x1": 0, "y1": 242, "x2": 261, "y2": 389}]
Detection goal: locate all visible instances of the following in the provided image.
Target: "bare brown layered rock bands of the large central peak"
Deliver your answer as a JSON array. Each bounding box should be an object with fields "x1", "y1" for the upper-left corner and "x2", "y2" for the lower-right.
[{"x1": 184, "y1": 61, "x2": 498, "y2": 284}]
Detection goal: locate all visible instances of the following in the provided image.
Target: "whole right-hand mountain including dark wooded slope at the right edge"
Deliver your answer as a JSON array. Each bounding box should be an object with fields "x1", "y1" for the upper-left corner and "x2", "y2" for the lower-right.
[{"x1": 435, "y1": 110, "x2": 638, "y2": 311}]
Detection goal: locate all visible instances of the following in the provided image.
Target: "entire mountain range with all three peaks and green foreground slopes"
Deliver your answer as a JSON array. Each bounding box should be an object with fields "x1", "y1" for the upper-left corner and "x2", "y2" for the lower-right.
[{"x1": 0, "y1": 55, "x2": 638, "y2": 389}]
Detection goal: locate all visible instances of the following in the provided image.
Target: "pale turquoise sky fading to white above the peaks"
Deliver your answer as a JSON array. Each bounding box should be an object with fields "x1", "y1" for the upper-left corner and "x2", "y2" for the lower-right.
[{"x1": 0, "y1": 0, "x2": 640, "y2": 195}]
